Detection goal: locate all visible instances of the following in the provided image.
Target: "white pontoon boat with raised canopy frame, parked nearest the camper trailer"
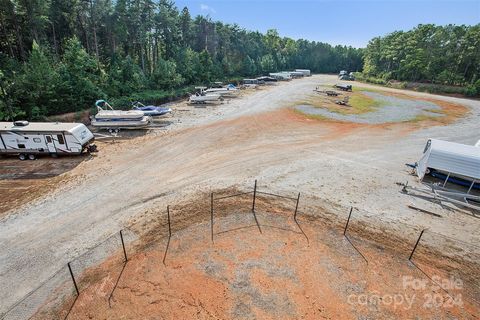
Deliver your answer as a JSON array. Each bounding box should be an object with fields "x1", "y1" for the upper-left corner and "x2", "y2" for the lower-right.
[{"x1": 91, "y1": 100, "x2": 152, "y2": 129}]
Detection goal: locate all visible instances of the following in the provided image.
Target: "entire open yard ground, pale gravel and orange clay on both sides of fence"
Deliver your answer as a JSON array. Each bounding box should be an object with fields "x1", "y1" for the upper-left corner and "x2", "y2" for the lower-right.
[{"x1": 0, "y1": 75, "x2": 480, "y2": 319}]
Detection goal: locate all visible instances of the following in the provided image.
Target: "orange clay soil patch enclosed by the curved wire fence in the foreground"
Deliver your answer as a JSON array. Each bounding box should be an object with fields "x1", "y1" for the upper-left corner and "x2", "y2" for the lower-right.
[{"x1": 44, "y1": 200, "x2": 480, "y2": 319}]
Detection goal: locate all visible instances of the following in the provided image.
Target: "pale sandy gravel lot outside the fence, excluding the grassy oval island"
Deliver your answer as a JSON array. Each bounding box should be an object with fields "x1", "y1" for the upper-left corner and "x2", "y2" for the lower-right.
[{"x1": 0, "y1": 75, "x2": 480, "y2": 313}]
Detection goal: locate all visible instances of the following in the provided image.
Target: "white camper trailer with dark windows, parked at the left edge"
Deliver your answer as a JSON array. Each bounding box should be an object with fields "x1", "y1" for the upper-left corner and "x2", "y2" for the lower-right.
[{"x1": 0, "y1": 121, "x2": 96, "y2": 160}]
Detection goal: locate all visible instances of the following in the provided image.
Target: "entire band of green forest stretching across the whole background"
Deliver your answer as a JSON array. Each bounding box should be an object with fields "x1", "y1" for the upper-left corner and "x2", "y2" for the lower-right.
[{"x1": 0, "y1": 0, "x2": 480, "y2": 120}]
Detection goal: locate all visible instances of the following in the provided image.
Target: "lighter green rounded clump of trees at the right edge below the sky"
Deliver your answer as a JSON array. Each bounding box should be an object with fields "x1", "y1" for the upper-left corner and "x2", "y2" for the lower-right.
[{"x1": 364, "y1": 24, "x2": 480, "y2": 95}]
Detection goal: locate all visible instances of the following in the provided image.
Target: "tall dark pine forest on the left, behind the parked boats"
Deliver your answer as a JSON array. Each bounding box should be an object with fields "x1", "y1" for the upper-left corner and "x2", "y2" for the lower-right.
[{"x1": 0, "y1": 0, "x2": 362, "y2": 119}]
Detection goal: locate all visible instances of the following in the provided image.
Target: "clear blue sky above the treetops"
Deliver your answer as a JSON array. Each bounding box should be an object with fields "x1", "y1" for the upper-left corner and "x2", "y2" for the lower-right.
[{"x1": 176, "y1": 0, "x2": 480, "y2": 47}]
